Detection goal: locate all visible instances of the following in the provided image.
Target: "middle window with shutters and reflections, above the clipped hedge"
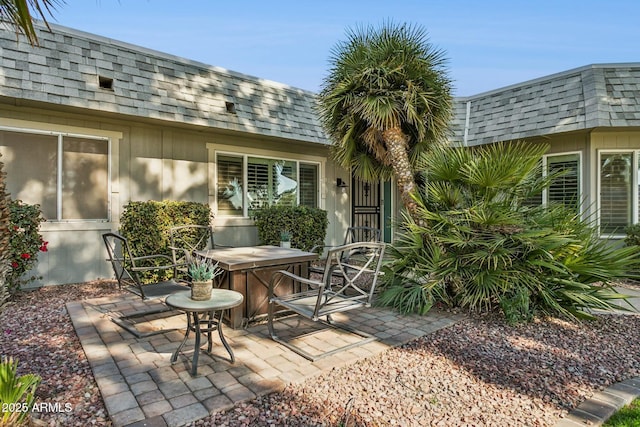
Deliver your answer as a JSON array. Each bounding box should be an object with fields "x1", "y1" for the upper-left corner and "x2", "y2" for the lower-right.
[{"x1": 216, "y1": 153, "x2": 320, "y2": 217}]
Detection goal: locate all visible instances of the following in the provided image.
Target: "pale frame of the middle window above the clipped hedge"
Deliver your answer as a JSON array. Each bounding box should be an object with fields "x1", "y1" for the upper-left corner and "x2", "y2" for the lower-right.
[{"x1": 211, "y1": 146, "x2": 324, "y2": 220}]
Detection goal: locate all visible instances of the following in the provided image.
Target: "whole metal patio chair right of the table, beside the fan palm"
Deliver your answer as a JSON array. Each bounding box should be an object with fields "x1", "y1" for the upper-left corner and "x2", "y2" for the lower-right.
[{"x1": 267, "y1": 242, "x2": 385, "y2": 361}]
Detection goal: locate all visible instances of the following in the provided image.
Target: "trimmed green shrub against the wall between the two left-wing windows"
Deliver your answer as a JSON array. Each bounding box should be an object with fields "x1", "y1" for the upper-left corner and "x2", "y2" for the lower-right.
[{"x1": 120, "y1": 200, "x2": 212, "y2": 282}]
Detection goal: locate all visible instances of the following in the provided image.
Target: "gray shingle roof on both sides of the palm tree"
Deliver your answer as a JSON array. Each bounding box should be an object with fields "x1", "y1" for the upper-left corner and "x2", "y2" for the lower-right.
[{"x1": 0, "y1": 25, "x2": 640, "y2": 145}]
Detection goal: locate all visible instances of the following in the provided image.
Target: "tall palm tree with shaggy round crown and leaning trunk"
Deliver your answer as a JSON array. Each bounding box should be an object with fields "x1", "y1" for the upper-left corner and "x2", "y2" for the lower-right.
[{"x1": 318, "y1": 23, "x2": 452, "y2": 216}]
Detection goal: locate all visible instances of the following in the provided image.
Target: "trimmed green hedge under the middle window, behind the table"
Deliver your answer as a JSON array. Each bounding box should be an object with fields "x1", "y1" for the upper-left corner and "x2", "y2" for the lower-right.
[{"x1": 254, "y1": 206, "x2": 329, "y2": 251}]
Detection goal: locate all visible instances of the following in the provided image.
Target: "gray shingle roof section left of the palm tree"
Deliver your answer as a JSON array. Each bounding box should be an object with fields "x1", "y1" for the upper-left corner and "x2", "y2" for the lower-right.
[{"x1": 0, "y1": 25, "x2": 329, "y2": 144}]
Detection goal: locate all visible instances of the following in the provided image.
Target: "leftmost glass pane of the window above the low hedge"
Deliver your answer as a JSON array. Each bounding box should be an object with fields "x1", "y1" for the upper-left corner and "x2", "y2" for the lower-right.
[{"x1": 216, "y1": 155, "x2": 243, "y2": 216}]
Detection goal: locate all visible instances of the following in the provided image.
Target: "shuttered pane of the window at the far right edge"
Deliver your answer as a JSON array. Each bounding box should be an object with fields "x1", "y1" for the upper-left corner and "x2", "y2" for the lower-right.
[{"x1": 600, "y1": 153, "x2": 632, "y2": 234}]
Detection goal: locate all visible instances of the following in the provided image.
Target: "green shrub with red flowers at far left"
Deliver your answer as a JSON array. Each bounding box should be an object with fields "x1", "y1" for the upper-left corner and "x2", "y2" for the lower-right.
[{"x1": 7, "y1": 200, "x2": 49, "y2": 293}]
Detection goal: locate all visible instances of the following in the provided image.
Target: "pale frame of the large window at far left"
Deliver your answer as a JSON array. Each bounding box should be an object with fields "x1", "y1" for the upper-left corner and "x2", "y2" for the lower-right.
[{"x1": 0, "y1": 124, "x2": 113, "y2": 224}]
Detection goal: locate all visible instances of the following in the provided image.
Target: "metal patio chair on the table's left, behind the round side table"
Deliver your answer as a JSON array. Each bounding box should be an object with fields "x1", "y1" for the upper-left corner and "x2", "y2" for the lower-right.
[{"x1": 102, "y1": 233, "x2": 190, "y2": 337}]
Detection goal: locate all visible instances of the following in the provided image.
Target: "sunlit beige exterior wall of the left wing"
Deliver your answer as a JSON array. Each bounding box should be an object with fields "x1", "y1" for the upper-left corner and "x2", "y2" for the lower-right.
[{"x1": 0, "y1": 103, "x2": 342, "y2": 286}]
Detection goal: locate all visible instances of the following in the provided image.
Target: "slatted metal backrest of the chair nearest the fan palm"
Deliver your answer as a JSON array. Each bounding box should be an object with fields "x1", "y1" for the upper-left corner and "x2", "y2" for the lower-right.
[{"x1": 316, "y1": 242, "x2": 385, "y2": 315}]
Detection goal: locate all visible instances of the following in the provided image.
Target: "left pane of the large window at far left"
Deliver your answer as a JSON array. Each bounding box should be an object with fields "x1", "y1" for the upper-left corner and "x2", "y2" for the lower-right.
[{"x1": 0, "y1": 131, "x2": 58, "y2": 220}]
